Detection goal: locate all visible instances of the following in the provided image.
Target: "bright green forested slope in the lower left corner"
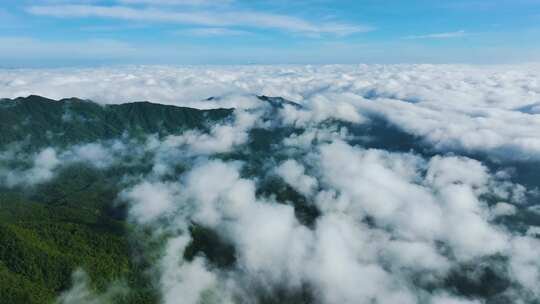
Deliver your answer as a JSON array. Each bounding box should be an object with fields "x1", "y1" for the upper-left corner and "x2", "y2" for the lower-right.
[{"x1": 0, "y1": 166, "x2": 160, "y2": 303}]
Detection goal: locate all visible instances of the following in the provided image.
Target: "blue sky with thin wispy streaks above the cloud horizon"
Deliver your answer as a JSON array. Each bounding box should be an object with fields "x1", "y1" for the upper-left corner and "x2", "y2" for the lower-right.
[{"x1": 0, "y1": 0, "x2": 540, "y2": 67}]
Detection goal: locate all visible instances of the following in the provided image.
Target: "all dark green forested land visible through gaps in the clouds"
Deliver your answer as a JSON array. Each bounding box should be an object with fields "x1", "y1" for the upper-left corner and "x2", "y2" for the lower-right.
[{"x1": 0, "y1": 96, "x2": 540, "y2": 304}]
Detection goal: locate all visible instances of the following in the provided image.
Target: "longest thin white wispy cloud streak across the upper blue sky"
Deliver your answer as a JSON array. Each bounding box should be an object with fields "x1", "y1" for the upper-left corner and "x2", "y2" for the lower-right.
[{"x1": 27, "y1": 5, "x2": 373, "y2": 36}]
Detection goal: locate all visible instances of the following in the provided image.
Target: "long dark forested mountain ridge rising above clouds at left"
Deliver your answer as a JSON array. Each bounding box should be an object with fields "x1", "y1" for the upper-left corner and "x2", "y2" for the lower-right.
[{"x1": 0, "y1": 95, "x2": 233, "y2": 148}]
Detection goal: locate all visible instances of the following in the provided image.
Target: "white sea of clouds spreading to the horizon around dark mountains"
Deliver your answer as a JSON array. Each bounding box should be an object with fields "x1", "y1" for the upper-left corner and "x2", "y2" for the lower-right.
[{"x1": 0, "y1": 65, "x2": 540, "y2": 304}]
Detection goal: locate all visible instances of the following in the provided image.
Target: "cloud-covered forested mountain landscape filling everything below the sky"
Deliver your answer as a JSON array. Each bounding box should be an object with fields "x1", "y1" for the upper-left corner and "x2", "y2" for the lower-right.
[{"x1": 0, "y1": 65, "x2": 540, "y2": 304}]
